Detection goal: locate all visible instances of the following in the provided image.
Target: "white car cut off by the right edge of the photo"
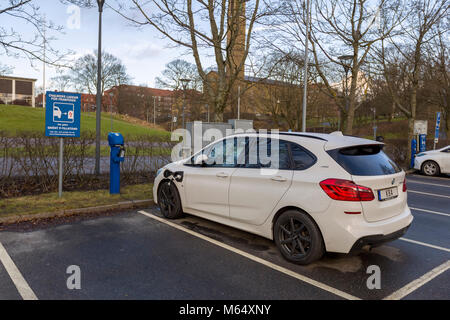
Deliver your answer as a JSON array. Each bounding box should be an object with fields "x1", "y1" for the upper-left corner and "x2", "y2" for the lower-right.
[{"x1": 414, "y1": 146, "x2": 450, "y2": 176}]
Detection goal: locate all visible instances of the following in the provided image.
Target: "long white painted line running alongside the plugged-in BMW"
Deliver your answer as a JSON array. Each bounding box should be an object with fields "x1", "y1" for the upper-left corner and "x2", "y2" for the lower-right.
[{"x1": 138, "y1": 210, "x2": 361, "y2": 300}]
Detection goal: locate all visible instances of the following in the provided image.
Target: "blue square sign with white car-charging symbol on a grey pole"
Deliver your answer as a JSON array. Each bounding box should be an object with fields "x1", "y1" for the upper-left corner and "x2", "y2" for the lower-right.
[{"x1": 45, "y1": 91, "x2": 81, "y2": 138}]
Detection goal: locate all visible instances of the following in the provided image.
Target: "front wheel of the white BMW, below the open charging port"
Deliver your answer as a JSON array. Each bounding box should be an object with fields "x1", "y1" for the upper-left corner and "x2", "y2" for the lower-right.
[{"x1": 158, "y1": 180, "x2": 183, "y2": 219}]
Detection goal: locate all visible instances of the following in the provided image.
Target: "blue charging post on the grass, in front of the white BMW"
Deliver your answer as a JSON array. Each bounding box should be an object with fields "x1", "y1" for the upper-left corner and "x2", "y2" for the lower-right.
[{"x1": 108, "y1": 132, "x2": 125, "y2": 194}]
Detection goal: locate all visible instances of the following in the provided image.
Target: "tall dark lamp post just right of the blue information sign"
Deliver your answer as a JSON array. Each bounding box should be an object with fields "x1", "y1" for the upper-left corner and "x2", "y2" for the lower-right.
[{"x1": 94, "y1": 0, "x2": 105, "y2": 175}]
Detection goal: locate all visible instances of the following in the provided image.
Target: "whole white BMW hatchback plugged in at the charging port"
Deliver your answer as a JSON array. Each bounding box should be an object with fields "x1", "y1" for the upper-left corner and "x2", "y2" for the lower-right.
[{"x1": 153, "y1": 132, "x2": 413, "y2": 264}]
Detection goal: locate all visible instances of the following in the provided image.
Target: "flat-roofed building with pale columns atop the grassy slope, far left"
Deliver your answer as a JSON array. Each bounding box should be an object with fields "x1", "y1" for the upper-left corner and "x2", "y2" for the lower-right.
[{"x1": 0, "y1": 76, "x2": 36, "y2": 108}]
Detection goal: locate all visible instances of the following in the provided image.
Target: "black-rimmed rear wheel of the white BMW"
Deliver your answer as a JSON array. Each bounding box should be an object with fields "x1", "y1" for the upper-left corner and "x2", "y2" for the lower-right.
[{"x1": 273, "y1": 210, "x2": 325, "y2": 265}]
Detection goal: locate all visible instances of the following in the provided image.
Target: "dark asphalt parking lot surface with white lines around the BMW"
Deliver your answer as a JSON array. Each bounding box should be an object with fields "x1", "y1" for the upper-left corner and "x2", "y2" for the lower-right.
[{"x1": 0, "y1": 175, "x2": 450, "y2": 300}]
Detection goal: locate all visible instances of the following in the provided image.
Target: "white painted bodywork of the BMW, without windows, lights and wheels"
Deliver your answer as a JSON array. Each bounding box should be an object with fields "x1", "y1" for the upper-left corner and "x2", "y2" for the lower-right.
[{"x1": 153, "y1": 133, "x2": 413, "y2": 253}]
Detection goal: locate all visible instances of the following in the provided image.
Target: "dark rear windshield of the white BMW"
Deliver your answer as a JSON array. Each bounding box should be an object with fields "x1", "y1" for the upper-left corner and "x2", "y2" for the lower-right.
[{"x1": 328, "y1": 145, "x2": 401, "y2": 176}]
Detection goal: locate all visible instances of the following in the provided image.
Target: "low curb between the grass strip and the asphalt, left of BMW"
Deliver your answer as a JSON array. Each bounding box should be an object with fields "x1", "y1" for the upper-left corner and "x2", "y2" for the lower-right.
[{"x1": 0, "y1": 200, "x2": 155, "y2": 225}]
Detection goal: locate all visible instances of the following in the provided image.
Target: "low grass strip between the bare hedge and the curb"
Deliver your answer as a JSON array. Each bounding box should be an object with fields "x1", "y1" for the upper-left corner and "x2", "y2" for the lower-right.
[{"x1": 0, "y1": 183, "x2": 153, "y2": 217}]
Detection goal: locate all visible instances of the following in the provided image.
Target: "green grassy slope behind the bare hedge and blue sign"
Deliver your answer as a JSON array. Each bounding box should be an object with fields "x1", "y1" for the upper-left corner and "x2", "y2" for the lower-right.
[{"x1": 0, "y1": 104, "x2": 170, "y2": 140}]
